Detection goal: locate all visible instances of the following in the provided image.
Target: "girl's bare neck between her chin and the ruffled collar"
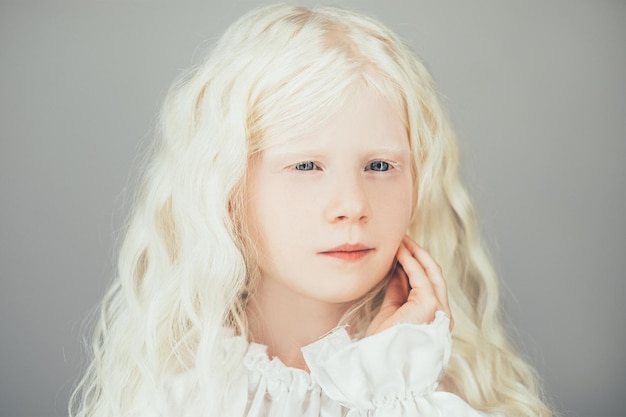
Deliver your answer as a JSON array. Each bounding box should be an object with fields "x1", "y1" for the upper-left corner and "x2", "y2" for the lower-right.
[{"x1": 246, "y1": 280, "x2": 349, "y2": 370}]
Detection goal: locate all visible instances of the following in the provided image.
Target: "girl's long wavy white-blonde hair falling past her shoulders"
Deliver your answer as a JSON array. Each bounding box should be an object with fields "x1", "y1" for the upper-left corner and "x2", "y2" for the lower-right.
[{"x1": 70, "y1": 5, "x2": 551, "y2": 417}]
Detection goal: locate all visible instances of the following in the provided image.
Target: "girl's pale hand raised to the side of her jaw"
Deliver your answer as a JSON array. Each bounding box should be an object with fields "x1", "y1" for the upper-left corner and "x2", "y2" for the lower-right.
[{"x1": 366, "y1": 236, "x2": 454, "y2": 336}]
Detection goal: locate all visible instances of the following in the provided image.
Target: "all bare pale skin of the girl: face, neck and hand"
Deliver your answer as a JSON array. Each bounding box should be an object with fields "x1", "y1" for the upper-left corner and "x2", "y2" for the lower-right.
[{"x1": 246, "y1": 85, "x2": 451, "y2": 369}]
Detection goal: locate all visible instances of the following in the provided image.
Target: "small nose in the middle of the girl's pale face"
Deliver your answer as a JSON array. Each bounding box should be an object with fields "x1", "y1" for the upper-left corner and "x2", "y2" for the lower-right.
[{"x1": 325, "y1": 175, "x2": 372, "y2": 223}]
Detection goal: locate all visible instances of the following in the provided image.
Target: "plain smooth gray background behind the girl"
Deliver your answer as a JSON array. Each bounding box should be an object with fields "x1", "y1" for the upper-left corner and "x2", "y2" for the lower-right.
[{"x1": 0, "y1": 0, "x2": 626, "y2": 417}]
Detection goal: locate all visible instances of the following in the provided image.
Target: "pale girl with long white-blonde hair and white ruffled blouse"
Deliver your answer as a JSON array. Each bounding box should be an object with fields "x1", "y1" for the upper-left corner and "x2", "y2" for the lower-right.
[{"x1": 72, "y1": 5, "x2": 550, "y2": 416}]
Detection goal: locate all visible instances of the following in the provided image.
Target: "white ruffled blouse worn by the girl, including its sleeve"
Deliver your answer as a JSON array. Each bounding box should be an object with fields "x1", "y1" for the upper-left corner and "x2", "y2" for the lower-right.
[{"x1": 150, "y1": 311, "x2": 488, "y2": 417}]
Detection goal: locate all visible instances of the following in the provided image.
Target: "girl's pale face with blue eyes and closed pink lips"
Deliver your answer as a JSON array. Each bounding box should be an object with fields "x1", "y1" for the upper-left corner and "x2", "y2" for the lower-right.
[{"x1": 247, "y1": 86, "x2": 413, "y2": 304}]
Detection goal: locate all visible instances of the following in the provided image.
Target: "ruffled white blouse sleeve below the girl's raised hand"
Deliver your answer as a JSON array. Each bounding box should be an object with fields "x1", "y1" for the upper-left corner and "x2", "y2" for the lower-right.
[{"x1": 302, "y1": 311, "x2": 494, "y2": 417}]
